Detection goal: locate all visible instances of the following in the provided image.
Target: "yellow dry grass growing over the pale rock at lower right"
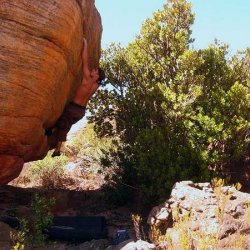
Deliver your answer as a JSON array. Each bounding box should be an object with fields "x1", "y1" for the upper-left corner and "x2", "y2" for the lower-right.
[{"x1": 150, "y1": 179, "x2": 250, "y2": 250}]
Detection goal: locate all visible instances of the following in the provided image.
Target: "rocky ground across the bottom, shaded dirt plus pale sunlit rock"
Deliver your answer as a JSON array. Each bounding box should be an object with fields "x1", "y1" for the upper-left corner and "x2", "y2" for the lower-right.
[{"x1": 0, "y1": 150, "x2": 250, "y2": 250}]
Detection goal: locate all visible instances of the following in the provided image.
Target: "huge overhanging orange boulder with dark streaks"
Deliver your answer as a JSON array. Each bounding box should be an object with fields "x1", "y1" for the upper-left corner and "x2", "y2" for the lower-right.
[{"x1": 0, "y1": 0, "x2": 102, "y2": 185}]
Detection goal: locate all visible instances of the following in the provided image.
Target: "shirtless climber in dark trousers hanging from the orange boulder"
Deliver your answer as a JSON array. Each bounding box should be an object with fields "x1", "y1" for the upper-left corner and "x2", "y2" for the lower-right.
[{"x1": 46, "y1": 39, "x2": 105, "y2": 157}]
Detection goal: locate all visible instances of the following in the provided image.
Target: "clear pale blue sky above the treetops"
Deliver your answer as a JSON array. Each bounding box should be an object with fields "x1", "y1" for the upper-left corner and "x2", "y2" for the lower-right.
[{"x1": 95, "y1": 0, "x2": 250, "y2": 52}]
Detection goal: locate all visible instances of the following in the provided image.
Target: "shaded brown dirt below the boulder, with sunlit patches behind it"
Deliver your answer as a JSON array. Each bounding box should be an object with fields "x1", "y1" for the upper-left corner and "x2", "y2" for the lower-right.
[{"x1": 0, "y1": 155, "x2": 150, "y2": 250}]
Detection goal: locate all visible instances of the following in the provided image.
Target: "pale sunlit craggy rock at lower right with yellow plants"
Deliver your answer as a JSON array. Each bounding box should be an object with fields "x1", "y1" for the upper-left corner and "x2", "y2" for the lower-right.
[{"x1": 148, "y1": 181, "x2": 250, "y2": 249}]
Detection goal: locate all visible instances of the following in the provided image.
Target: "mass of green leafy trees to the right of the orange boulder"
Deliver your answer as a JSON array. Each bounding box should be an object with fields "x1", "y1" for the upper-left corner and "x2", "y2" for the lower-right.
[{"x1": 90, "y1": 0, "x2": 250, "y2": 204}]
